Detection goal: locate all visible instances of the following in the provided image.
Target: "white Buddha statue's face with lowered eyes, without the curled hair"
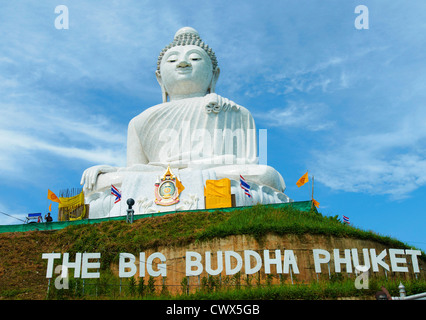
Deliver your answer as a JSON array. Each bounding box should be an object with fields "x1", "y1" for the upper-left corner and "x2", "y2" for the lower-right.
[{"x1": 157, "y1": 45, "x2": 213, "y2": 100}]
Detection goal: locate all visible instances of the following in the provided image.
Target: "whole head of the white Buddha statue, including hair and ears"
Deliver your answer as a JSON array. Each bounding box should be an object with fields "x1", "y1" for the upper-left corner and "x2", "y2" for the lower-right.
[{"x1": 155, "y1": 27, "x2": 220, "y2": 102}]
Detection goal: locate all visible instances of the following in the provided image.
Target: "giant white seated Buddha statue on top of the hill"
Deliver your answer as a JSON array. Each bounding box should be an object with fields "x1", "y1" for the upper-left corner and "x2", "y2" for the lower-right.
[{"x1": 81, "y1": 27, "x2": 290, "y2": 217}]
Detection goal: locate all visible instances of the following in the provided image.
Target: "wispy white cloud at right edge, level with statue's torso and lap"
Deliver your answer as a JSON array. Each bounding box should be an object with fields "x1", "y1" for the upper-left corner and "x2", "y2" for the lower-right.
[{"x1": 311, "y1": 110, "x2": 426, "y2": 199}]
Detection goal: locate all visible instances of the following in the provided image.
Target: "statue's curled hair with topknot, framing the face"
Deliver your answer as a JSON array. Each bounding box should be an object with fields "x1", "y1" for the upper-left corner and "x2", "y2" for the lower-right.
[{"x1": 157, "y1": 27, "x2": 217, "y2": 72}]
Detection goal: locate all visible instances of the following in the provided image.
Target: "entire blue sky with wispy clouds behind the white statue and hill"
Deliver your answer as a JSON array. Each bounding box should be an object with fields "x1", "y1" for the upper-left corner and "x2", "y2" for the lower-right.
[{"x1": 0, "y1": 0, "x2": 426, "y2": 251}]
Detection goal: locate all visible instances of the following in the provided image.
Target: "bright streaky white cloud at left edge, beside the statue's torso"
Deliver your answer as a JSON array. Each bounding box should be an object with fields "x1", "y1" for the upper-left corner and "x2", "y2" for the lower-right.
[{"x1": 0, "y1": 104, "x2": 126, "y2": 180}]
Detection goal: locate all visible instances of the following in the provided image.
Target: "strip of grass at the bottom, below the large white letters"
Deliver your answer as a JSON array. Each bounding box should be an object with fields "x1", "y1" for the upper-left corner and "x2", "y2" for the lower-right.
[{"x1": 47, "y1": 275, "x2": 426, "y2": 300}]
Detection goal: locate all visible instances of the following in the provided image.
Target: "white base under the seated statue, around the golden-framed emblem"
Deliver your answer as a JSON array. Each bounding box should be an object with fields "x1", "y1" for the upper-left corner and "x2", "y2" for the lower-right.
[{"x1": 86, "y1": 169, "x2": 291, "y2": 218}]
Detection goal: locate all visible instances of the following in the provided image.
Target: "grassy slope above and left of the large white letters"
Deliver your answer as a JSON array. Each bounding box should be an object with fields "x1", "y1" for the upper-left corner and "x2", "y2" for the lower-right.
[{"x1": 0, "y1": 205, "x2": 426, "y2": 299}]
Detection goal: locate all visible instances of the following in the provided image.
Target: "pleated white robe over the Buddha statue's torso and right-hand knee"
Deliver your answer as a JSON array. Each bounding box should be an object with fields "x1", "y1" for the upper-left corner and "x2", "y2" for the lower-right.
[{"x1": 125, "y1": 94, "x2": 285, "y2": 192}]
